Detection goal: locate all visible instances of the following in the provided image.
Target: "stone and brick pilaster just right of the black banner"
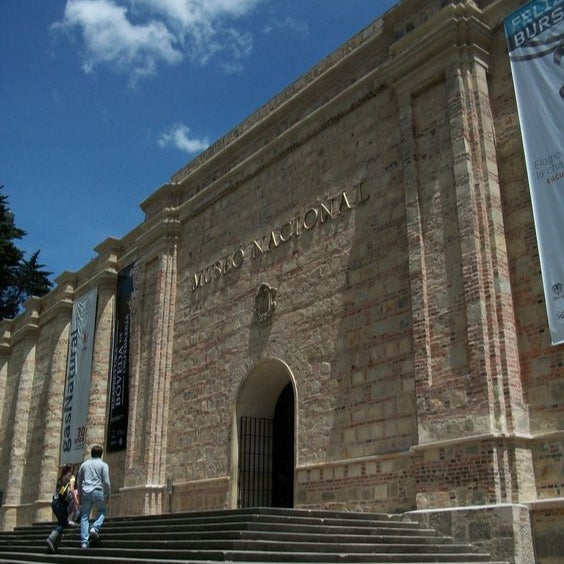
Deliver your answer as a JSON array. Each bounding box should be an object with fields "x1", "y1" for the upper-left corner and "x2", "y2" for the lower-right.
[{"x1": 124, "y1": 200, "x2": 179, "y2": 513}]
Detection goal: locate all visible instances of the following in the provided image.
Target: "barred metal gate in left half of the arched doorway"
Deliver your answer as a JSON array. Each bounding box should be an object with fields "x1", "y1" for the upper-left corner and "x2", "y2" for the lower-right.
[{"x1": 238, "y1": 417, "x2": 273, "y2": 507}]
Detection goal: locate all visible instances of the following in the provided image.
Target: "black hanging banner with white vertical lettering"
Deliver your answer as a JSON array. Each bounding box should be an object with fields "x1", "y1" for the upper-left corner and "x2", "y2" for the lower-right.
[{"x1": 107, "y1": 264, "x2": 134, "y2": 452}]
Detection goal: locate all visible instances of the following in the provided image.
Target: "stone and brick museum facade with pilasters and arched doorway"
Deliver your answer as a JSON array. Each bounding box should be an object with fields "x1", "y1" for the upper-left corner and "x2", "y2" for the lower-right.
[{"x1": 0, "y1": 0, "x2": 564, "y2": 564}]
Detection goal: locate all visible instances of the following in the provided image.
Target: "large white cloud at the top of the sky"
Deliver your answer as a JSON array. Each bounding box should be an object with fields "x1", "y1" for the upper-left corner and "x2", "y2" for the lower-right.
[{"x1": 53, "y1": 0, "x2": 264, "y2": 82}]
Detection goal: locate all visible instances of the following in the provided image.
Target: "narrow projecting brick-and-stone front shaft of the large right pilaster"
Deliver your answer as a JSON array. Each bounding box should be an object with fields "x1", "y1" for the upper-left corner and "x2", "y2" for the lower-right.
[{"x1": 448, "y1": 52, "x2": 529, "y2": 433}]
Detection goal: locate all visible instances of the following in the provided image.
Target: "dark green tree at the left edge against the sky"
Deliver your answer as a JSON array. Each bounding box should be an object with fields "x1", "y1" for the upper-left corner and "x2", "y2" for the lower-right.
[{"x1": 0, "y1": 186, "x2": 53, "y2": 319}]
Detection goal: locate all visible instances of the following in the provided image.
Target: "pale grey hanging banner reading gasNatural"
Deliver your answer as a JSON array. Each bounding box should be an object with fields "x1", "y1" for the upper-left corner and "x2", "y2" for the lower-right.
[{"x1": 61, "y1": 288, "x2": 98, "y2": 465}]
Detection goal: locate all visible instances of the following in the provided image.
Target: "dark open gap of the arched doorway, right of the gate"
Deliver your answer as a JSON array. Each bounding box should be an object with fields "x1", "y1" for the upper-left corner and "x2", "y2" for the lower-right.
[{"x1": 272, "y1": 384, "x2": 294, "y2": 507}]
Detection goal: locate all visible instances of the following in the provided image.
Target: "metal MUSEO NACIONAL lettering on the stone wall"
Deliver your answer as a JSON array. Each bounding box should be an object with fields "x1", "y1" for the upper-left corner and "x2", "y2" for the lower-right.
[{"x1": 191, "y1": 184, "x2": 368, "y2": 291}]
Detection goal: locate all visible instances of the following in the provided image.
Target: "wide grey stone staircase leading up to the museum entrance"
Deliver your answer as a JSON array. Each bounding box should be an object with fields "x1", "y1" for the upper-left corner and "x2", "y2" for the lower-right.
[{"x1": 0, "y1": 508, "x2": 506, "y2": 564}]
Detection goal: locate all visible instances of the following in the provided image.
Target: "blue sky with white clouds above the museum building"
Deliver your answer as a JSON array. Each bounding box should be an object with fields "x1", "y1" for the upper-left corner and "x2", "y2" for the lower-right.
[{"x1": 0, "y1": 0, "x2": 397, "y2": 278}]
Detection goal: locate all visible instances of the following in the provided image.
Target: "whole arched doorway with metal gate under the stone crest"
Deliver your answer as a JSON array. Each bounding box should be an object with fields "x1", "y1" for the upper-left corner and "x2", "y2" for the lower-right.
[{"x1": 232, "y1": 359, "x2": 295, "y2": 507}]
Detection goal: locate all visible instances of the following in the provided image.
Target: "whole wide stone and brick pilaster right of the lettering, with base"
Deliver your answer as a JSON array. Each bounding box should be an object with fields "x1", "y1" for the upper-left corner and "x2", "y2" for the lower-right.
[{"x1": 396, "y1": 1, "x2": 535, "y2": 508}]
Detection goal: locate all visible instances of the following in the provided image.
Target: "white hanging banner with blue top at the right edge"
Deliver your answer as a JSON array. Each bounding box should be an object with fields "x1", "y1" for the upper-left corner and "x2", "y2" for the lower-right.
[{"x1": 504, "y1": 0, "x2": 564, "y2": 345}]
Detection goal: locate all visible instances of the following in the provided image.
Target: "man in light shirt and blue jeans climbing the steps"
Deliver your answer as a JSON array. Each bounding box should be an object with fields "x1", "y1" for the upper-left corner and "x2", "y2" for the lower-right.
[{"x1": 76, "y1": 445, "x2": 111, "y2": 548}]
